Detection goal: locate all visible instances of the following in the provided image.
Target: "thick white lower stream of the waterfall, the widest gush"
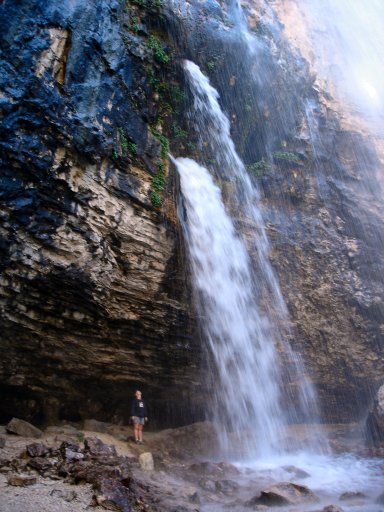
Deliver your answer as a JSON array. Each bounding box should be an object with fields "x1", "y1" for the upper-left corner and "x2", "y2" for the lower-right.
[{"x1": 176, "y1": 158, "x2": 282, "y2": 452}]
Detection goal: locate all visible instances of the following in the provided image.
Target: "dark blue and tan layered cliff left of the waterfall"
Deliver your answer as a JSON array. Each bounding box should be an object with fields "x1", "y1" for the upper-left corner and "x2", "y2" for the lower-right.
[{"x1": 0, "y1": 1, "x2": 199, "y2": 422}]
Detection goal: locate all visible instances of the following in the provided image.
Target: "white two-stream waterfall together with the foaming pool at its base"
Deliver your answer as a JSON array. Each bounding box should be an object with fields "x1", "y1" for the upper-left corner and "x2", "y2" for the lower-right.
[{"x1": 173, "y1": 2, "x2": 383, "y2": 512}]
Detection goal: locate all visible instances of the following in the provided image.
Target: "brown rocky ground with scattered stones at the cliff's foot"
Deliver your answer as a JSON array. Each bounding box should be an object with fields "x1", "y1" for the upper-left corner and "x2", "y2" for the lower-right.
[{"x1": 0, "y1": 420, "x2": 384, "y2": 512}]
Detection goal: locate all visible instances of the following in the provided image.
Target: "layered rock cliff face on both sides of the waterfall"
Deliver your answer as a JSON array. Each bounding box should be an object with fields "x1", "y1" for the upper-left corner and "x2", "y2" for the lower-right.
[{"x1": 0, "y1": 0, "x2": 384, "y2": 423}]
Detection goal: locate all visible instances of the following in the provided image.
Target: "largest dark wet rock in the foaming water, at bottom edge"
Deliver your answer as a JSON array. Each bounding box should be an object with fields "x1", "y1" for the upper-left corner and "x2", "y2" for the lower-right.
[{"x1": 246, "y1": 482, "x2": 319, "y2": 507}]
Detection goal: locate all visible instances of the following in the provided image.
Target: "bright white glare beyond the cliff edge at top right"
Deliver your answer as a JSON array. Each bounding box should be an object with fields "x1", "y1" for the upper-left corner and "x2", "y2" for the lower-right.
[{"x1": 294, "y1": 0, "x2": 384, "y2": 127}]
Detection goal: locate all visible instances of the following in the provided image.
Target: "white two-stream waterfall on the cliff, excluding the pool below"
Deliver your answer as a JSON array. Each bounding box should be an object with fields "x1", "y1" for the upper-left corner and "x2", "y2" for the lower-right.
[{"x1": 175, "y1": 61, "x2": 320, "y2": 457}]
